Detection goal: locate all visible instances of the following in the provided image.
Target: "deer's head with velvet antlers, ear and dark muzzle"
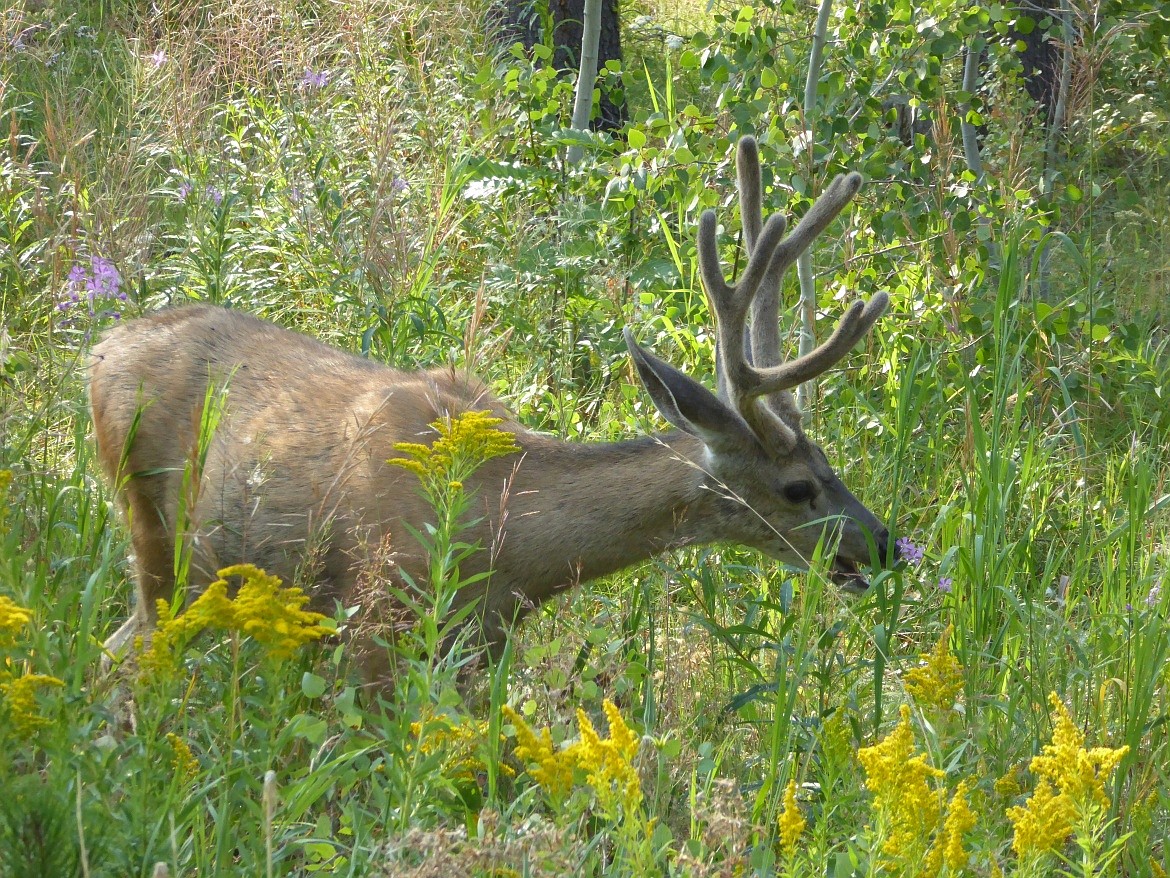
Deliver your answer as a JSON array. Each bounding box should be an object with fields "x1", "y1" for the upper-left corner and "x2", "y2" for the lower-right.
[{"x1": 626, "y1": 137, "x2": 889, "y2": 590}]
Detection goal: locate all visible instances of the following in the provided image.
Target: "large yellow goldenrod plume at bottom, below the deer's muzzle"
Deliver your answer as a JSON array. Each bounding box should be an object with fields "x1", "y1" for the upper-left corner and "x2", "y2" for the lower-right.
[{"x1": 858, "y1": 705, "x2": 943, "y2": 858}]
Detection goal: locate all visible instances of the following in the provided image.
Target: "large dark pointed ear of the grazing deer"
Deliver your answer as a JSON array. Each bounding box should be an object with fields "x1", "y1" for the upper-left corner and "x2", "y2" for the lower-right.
[{"x1": 625, "y1": 327, "x2": 759, "y2": 452}]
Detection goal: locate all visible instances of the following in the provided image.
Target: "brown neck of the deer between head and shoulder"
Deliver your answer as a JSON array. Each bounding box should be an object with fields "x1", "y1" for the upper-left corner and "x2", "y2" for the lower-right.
[{"x1": 495, "y1": 432, "x2": 714, "y2": 602}]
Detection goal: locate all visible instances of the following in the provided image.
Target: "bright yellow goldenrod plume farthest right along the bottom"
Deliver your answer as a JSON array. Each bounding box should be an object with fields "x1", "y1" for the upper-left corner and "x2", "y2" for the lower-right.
[{"x1": 1007, "y1": 692, "x2": 1129, "y2": 856}]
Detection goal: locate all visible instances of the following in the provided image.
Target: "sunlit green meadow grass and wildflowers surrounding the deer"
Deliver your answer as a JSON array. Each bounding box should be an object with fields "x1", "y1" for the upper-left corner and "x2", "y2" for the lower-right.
[{"x1": 0, "y1": 0, "x2": 1170, "y2": 878}]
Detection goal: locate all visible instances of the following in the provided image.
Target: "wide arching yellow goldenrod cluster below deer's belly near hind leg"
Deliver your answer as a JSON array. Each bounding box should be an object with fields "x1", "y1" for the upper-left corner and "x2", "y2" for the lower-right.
[{"x1": 139, "y1": 564, "x2": 332, "y2": 674}]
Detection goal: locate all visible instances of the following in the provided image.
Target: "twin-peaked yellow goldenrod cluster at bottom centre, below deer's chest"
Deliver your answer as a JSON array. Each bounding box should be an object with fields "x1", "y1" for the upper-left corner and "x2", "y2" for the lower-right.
[{"x1": 504, "y1": 699, "x2": 642, "y2": 815}]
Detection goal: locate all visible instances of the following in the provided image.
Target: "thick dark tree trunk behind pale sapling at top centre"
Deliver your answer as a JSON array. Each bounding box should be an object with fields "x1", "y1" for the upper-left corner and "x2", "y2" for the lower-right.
[{"x1": 501, "y1": 0, "x2": 626, "y2": 131}]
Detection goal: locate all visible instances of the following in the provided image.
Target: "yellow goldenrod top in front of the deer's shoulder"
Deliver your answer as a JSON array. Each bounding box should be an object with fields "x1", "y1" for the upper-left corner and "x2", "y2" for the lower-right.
[{"x1": 387, "y1": 411, "x2": 521, "y2": 489}]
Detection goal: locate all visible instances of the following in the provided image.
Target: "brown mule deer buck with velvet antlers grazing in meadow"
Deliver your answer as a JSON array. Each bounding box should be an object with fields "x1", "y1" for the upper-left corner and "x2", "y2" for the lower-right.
[{"x1": 89, "y1": 137, "x2": 889, "y2": 680}]
